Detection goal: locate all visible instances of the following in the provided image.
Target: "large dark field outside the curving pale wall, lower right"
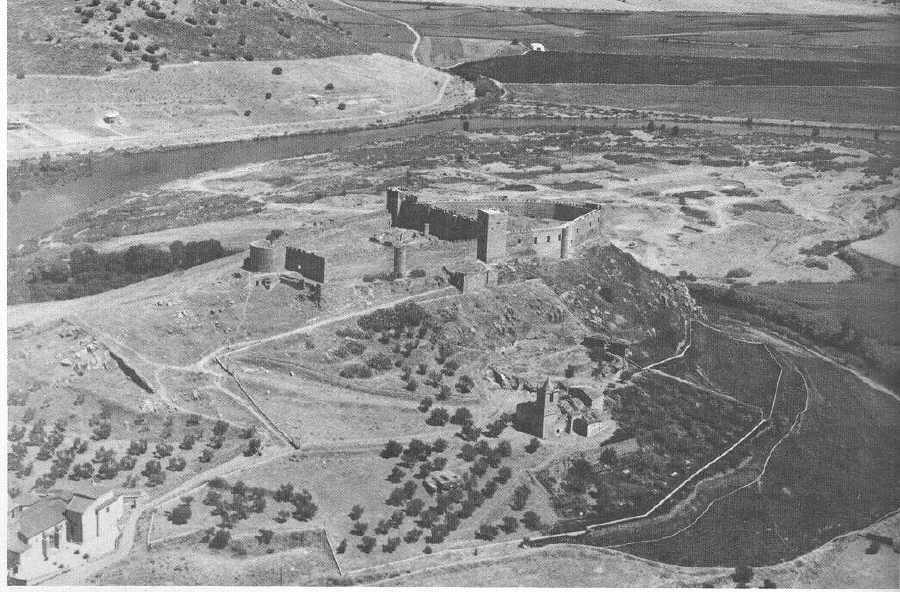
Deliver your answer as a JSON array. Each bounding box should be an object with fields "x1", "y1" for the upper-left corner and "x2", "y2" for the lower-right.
[{"x1": 604, "y1": 358, "x2": 900, "y2": 566}]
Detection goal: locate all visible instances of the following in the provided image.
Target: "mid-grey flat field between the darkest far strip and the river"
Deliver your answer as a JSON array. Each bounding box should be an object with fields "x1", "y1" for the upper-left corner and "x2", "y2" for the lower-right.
[{"x1": 507, "y1": 83, "x2": 898, "y2": 125}]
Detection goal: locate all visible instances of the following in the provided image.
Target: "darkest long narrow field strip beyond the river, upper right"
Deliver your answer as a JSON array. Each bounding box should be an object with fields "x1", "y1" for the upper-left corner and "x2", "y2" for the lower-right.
[{"x1": 451, "y1": 52, "x2": 900, "y2": 86}]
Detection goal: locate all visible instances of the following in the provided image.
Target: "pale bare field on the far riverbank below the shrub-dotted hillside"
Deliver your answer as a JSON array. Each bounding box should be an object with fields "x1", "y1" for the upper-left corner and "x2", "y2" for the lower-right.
[{"x1": 8, "y1": 55, "x2": 458, "y2": 150}]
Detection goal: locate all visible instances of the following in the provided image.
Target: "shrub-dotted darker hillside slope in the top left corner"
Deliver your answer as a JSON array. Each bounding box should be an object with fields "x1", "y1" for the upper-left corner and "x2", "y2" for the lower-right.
[{"x1": 7, "y1": 0, "x2": 360, "y2": 76}]
